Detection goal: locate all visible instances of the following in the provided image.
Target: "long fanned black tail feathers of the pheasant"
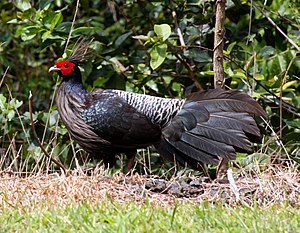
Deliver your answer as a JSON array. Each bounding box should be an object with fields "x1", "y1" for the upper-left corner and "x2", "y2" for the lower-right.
[{"x1": 156, "y1": 89, "x2": 266, "y2": 168}]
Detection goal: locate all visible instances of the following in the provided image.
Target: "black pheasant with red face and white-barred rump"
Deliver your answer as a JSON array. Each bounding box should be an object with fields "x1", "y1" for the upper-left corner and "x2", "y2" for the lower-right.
[{"x1": 49, "y1": 40, "x2": 265, "y2": 171}]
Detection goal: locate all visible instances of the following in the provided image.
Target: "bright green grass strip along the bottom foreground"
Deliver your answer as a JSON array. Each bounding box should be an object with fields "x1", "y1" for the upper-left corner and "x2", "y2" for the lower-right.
[{"x1": 0, "y1": 199, "x2": 300, "y2": 233}]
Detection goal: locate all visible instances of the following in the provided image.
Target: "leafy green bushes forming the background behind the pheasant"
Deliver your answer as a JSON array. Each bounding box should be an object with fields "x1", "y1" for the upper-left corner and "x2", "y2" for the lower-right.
[{"x1": 0, "y1": 0, "x2": 300, "y2": 174}]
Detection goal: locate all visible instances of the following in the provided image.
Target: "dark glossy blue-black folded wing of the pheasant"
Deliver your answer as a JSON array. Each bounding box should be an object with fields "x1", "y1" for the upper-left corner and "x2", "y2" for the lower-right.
[{"x1": 81, "y1": 91, "x2": 161, "y2": 148}]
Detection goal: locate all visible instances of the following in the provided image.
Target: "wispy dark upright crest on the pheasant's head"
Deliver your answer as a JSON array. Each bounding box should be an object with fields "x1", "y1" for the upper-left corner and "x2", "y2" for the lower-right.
[{"x1": 67, "y1": 37, "x2": 93, "y2": 65}]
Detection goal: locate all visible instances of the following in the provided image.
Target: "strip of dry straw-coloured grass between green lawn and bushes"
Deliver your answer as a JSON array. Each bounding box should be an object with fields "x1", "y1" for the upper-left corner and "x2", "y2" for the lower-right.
[{"x1": 0, "y1": 163, "x2": 300, "y2": 211}]
